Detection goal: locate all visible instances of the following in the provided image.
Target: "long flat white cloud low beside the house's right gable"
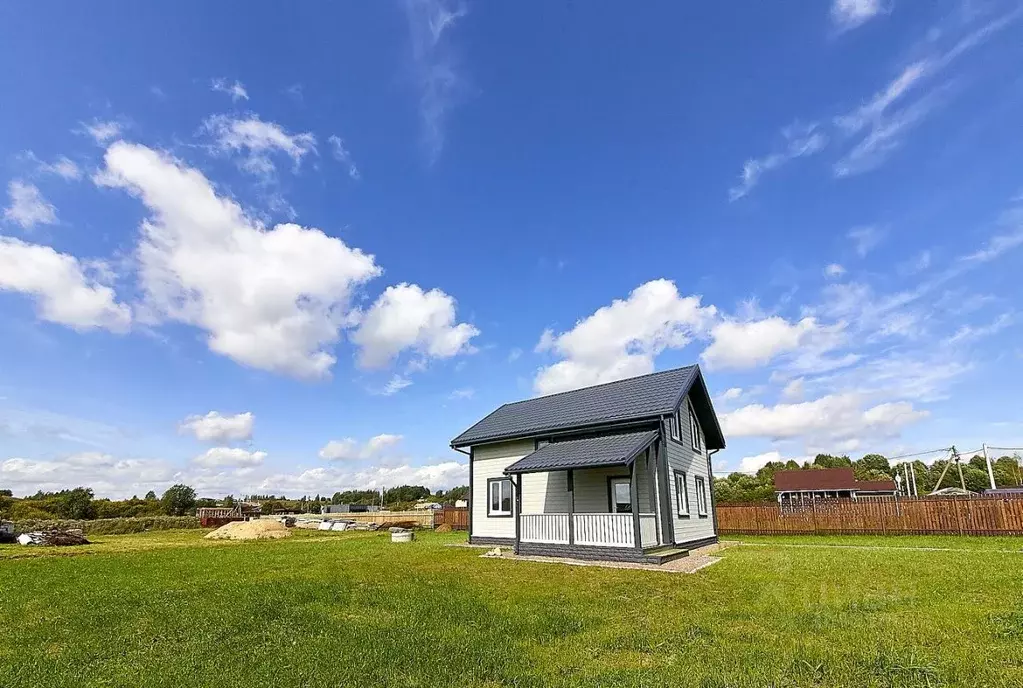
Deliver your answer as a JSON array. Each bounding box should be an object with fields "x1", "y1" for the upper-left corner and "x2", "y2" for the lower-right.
[{"x1": 721, "y1": 393, "x2": 928, "y2": 442}]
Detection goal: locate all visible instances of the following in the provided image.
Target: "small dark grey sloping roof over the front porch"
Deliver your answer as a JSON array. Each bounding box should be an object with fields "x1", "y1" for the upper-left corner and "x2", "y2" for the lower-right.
[{"x1": 504, "y1": 430, "x2": 658, "y2": 474}]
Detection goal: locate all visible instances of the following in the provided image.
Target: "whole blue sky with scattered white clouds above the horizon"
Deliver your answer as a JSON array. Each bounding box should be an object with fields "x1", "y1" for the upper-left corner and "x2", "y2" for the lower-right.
[{"x1": 0, "y1": 0, "x2": 1023, "y2": 496}]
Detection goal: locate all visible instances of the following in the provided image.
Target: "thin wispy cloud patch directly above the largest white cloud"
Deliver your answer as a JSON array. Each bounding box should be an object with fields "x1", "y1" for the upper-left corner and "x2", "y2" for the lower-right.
[{"x1": 204, "y1": 114, "x2": 316, "y2": 176}]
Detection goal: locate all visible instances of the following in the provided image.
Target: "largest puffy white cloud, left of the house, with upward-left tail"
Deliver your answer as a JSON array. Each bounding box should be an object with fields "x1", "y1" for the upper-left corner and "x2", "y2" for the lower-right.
[{"x1": 96, "y1": 142, "x2": 381, "y2": 377}]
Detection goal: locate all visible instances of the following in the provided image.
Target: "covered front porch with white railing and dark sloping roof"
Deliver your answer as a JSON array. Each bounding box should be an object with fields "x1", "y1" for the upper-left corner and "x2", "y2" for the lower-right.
[{"x1": 504, "y1": 430, "x2": 679, "y2": 560}]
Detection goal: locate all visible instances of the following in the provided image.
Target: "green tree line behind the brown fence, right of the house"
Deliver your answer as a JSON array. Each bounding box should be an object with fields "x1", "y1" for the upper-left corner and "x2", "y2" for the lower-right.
[{"x1": 714, "y1": 454, "x2": 1023, "y2": 504}]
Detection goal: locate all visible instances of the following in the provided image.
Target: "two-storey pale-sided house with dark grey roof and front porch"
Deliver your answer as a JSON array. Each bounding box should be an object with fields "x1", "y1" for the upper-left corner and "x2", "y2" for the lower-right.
[{"x1": 451, "y1": 365, "x2": 724, "y2": 562}]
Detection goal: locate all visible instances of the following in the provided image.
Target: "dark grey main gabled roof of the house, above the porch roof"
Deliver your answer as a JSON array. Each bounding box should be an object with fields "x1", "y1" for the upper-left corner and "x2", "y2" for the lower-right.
[{"x1": 451, "y1": 365, "x2": 707, "y2": 449}]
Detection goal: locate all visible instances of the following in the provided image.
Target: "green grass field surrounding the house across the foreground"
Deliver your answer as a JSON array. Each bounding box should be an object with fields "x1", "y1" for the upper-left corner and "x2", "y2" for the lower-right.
[{"x1": 0, "y1": 531, "x2": 1023, "y2": 688}]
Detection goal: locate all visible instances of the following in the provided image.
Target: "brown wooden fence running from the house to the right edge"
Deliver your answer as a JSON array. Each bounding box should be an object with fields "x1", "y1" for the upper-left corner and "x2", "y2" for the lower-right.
[{"x1": 717, "y1": 497, "x2": 1023, "y2": 535}]
